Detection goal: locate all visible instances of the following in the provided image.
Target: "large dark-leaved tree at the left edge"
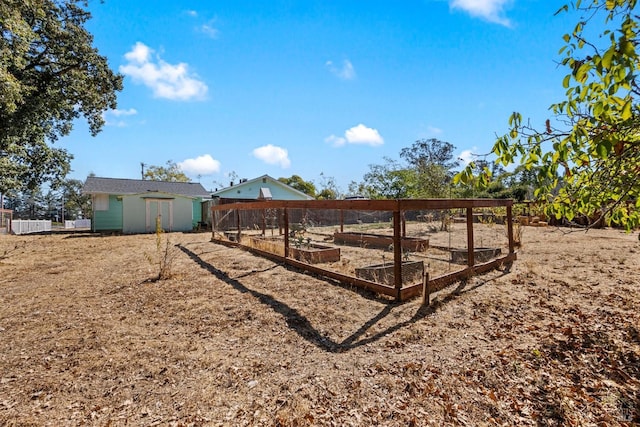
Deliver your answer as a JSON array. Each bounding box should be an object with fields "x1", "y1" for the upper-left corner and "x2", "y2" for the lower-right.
[{"x1": 0, "y1": 0, "x2": 122, "y2": 193}]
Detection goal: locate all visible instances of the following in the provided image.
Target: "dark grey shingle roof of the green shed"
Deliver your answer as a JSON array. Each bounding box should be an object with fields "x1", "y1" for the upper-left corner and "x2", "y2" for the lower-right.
[{"x1": 82, "y1": 176, "x2": 211, "y2": 198}]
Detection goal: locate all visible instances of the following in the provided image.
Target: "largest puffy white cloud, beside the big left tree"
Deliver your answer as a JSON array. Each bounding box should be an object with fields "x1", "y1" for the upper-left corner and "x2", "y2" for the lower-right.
[{"x1": 120, "y1": 42, "x2": 208, "y2": 101}]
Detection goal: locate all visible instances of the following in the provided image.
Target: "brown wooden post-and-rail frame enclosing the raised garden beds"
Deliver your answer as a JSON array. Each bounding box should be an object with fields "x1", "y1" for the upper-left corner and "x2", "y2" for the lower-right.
[{"x1": 211, "y1": 199, "x2": 517, "y2": 301}]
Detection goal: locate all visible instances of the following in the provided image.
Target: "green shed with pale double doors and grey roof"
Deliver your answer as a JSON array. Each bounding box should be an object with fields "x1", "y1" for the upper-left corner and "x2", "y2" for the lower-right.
[{"x1": 82, "y1": 176, "x2": 210, "y2": 234}]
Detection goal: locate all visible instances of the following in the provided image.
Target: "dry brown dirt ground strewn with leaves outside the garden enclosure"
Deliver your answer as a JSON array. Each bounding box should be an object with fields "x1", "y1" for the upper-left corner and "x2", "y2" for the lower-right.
[{"x1": 0, "y1": 227, "x2": 640, "y2": 426}]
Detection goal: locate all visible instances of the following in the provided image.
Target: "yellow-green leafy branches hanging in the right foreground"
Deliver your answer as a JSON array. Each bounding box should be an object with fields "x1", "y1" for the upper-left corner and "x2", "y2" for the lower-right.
[{"x1": 456, "y1": 0, "x2": 640, "y2": 229}]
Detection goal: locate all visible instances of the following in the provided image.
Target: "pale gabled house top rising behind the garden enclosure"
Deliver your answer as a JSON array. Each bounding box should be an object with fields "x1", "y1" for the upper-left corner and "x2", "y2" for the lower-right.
[{"x1": 211, "y1": 175, "x2": 313, "y2": 204}]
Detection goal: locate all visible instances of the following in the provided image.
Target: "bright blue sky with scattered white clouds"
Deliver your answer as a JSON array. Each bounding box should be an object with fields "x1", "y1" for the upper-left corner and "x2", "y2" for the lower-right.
[{"x1": 56, "y1": 0, "x2": 576, "y2": 192}]
